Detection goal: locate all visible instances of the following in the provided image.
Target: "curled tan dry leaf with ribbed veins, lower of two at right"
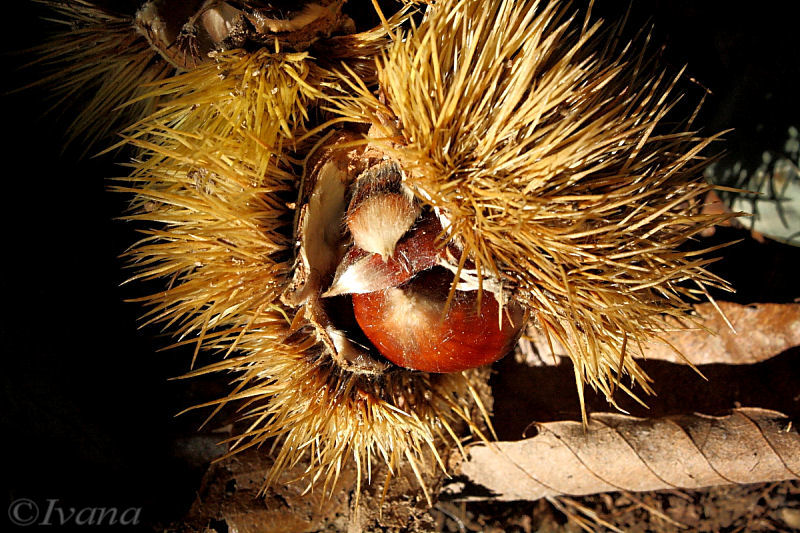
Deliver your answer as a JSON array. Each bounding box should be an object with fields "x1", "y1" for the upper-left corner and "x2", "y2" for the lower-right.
[{"x1": 445, "y1": 408, "x2": 800, "y2": 501}]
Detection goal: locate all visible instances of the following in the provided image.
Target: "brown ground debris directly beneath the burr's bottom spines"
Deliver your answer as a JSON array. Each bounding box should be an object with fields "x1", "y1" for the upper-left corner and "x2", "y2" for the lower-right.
[{"x1": 183, "y1": 444, "x2": 444, "y2": 533}]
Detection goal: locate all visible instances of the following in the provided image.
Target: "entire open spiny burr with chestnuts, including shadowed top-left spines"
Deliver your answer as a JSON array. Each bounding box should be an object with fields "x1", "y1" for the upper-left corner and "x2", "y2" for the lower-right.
[{"x1": 36, "y1": 0, "x2": 727, "y2": 508}]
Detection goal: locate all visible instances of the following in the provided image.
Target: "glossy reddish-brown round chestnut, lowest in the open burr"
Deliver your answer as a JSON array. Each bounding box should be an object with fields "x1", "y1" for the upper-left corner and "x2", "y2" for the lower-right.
[{"x1": 352, "y1": 267, "x2": 524, "y2": 372}]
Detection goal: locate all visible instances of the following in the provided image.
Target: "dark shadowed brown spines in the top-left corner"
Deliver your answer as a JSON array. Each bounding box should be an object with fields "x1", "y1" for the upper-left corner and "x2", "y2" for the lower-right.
[{"x1": 26, "y1": 0, "x2": 175, "y2": 155}]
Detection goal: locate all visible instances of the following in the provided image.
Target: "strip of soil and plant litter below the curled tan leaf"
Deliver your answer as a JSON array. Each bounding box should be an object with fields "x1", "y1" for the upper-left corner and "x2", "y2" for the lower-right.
[{"x1": 431, "y1": 481, "x2": 800, "y2": 533}]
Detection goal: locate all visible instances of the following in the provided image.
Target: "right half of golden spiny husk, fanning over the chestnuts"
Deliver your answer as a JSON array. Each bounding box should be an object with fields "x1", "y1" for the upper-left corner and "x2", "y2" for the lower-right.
[{"x1": 328, "y1": 0, "x2": 726, "y2": 412}]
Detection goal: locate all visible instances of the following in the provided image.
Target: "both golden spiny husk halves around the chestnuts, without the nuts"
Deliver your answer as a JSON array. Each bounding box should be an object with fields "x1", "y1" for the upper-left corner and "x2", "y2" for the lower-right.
[{"x1": 106, "y1": 0, "x2": 736, "y2": 498}]
